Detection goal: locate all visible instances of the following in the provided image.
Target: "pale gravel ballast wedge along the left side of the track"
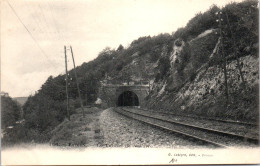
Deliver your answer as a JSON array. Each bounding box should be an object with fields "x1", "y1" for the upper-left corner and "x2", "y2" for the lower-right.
[{"x1": 100, "y1": 108, "x2": 202, "y2": 148}]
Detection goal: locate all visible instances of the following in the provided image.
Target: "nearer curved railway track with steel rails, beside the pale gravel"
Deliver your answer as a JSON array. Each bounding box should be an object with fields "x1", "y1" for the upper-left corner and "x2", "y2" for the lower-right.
[{"x1": 115, "y1": 108, "x2": 259, "y2": 148}]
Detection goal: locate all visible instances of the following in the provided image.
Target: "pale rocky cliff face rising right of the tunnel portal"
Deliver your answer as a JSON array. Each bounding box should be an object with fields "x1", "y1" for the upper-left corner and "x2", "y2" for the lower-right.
[{"x1": 146, "y1": 29, "x2": 259, "y2": 121}]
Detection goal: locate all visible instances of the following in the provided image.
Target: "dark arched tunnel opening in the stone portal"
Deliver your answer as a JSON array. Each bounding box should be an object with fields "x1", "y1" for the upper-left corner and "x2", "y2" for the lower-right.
[{"x1": 117, "y1": 91, "x2": 139, "y2": 106}]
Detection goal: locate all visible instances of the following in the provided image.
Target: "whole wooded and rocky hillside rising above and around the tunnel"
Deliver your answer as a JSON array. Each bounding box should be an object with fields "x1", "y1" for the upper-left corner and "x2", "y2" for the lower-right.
[{"x1": 8, "y1": 1, "x2": 259, "y2": 142}]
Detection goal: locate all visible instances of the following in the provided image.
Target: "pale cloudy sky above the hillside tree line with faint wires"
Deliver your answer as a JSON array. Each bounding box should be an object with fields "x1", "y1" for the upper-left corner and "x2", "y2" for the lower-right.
[{"x1": 1, "y1": 0, "x2": 241, "y2": 97}]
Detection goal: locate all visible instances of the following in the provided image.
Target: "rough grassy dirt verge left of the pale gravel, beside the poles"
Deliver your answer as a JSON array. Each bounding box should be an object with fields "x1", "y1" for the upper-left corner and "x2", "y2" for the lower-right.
[{"x1": 50, "y1": 107, "x2": 104, "y2": 147}]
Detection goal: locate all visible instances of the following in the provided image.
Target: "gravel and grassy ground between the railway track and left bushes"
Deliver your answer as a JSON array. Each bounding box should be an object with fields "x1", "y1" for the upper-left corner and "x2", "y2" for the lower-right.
[{"x1": 49, "y1": 108, "x2": 211, "y2": 148}]
